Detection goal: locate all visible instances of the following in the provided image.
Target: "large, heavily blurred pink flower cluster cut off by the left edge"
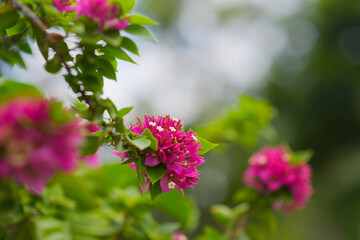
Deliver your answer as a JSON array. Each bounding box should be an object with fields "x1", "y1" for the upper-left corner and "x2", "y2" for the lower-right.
[{"x1": 0, "y1": 98, "x2": 98, "y2": 194}]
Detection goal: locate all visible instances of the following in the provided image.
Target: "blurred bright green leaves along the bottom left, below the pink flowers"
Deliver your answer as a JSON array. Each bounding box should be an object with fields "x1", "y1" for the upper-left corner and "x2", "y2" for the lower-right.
[{"x1": 0, "y1": 163, "x2": 198, "y2": 240}]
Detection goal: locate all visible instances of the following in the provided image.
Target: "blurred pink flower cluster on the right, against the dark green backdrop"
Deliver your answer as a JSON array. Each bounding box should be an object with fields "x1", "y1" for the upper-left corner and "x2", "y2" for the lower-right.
[{"x1": 244, "y1": 147, "x2": 312, "y2": 208}]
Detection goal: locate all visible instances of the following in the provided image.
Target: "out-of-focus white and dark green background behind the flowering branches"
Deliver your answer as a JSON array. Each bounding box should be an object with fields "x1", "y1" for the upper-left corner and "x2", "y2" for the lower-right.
[{"x1": 1, "y1": 0, "x2": 360, "y2": 240}]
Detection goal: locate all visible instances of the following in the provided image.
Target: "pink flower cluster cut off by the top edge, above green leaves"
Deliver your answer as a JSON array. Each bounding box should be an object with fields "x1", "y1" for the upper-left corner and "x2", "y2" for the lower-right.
[{"x1": 54, "y1": 0, "x2": 129, "y2": 30}]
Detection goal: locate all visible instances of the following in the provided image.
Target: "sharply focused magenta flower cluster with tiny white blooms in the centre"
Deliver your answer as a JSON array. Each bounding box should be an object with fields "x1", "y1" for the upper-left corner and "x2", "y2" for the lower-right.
[{"x1": 115, "y1": 115, "x2": 204, "y2": 192}]
